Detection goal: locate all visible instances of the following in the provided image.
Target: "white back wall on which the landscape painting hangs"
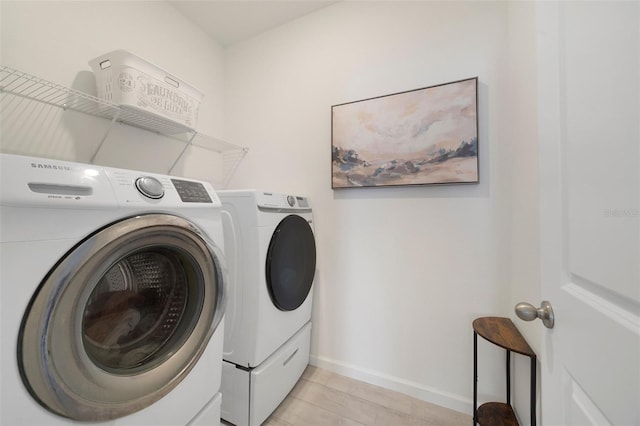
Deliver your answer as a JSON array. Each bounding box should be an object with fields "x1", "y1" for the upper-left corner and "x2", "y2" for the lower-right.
[{"x1": 225, "y1": 2, "x2": 512, "y2": 413}]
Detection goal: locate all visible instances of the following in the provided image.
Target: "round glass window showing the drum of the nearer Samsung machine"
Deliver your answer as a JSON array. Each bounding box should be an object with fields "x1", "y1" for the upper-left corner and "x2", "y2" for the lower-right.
[{"x1": 82, "y1": 247, "x2": 196, "y2": 374}]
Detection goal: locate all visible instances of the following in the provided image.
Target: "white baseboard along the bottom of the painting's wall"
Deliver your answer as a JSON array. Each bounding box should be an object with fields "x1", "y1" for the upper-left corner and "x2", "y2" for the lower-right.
[{"x1": 309, "y1": 355, "x2": 473, "y2": 415}]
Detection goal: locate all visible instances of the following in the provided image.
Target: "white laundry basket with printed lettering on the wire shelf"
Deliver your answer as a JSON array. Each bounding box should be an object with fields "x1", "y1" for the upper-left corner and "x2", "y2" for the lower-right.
[{"x1": 89, "y1": 50, "x2": 203, "y2": 129}]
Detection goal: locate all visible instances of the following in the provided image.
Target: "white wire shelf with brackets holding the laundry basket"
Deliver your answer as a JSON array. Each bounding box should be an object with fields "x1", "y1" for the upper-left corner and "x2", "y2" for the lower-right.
[{"x1": 0, "y1": 65, "x2": 248, "y2": 185}]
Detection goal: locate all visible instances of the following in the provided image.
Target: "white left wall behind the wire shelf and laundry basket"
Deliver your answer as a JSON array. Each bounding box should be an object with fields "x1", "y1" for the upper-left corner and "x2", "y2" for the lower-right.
[{"x1": 0, "y1": 0, "x2": 224, "y2": 177}]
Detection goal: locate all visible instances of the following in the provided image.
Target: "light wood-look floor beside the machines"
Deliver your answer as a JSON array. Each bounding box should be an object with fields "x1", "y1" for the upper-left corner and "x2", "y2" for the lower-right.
[{"x1": 264, "y1": 366, "x2": 472, "y2": 426}]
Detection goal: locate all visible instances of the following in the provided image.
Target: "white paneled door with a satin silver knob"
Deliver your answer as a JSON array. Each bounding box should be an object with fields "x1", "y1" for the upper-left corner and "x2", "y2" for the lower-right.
[{"x1": 537, "y1": 1, "x2": 640, "y2": 425}]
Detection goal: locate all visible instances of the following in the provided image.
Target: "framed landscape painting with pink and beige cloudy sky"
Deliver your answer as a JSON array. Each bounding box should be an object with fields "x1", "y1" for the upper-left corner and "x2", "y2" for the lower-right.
[{"x1": 331, "y1": 77, "x2": 479, "y2": 189}]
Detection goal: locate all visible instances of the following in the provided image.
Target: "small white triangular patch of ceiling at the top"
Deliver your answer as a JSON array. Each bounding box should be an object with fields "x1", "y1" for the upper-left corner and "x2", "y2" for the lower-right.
[{"x1": 169, "y1": 0, "x2": 336, "y2": 47}]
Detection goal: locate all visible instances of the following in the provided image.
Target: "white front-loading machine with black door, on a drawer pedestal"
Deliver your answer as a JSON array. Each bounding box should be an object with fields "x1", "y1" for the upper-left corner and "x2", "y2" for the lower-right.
[{"x1": 218, "y1": 190, "x2": 316, "y2": 426}]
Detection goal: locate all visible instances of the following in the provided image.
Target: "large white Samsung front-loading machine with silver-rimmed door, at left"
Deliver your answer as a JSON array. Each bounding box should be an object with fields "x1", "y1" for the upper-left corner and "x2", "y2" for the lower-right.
[{"x1": 0, "y1": 154, "x2": 227, "y2": 426}]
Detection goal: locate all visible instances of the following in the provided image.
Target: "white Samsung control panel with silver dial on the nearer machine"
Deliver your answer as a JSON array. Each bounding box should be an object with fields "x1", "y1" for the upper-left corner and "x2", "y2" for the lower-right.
[{"x1": 0, "y1": 153, "x2": 220, "y2": 209}]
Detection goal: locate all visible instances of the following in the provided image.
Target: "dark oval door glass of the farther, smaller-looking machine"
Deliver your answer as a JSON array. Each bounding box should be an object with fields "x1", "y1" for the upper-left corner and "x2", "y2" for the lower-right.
[{"x1": 266, "y1": 215, "x2": 316, "y2": 311}]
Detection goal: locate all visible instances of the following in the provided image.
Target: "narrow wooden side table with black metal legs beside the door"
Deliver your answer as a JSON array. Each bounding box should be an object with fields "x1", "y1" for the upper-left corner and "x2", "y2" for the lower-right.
[{"x1": 473, "y1": 317, "x2": 536, "y2": 426}]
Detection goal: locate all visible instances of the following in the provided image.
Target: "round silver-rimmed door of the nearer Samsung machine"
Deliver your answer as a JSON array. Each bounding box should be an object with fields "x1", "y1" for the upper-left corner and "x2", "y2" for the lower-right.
[{"x1": 18, "y1": 214, "x2": 226, "y2": 421}]
